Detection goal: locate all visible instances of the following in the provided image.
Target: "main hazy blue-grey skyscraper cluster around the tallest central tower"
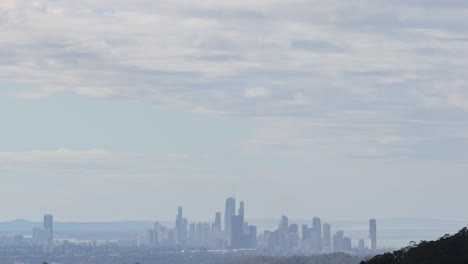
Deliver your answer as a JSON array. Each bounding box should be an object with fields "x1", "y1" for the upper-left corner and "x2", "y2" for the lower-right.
[{"x1": 138, "y1": 197, "x2": 377, "y2": 254}]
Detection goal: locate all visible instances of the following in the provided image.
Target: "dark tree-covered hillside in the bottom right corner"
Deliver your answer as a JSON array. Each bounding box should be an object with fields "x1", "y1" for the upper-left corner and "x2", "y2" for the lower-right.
[{"x1": 361, "y1": 228, "x2": 468, "y2": 264}]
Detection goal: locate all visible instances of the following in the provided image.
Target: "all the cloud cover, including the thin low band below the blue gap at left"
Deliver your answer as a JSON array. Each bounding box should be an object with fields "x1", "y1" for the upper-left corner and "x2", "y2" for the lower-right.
[{"x1": 0, "y1": 0, "x2": 468, "y2": 221}]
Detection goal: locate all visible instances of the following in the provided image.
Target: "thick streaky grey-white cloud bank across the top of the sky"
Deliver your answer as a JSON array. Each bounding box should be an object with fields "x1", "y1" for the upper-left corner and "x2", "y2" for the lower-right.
[{"x1": 0, "y1": 0, "x2": 468, "y2": 163}]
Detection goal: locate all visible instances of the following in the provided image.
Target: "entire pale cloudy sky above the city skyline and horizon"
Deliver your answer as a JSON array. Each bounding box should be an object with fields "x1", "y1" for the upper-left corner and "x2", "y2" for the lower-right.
[{"x1": 0, "y1": 0, "x2": 468, "y2": 221}]
